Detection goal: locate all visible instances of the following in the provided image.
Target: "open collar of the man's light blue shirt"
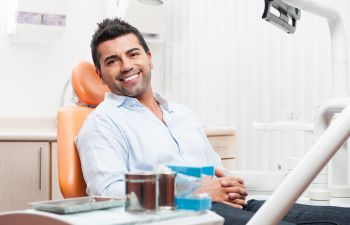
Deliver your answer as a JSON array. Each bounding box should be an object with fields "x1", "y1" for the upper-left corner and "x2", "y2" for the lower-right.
[{"x1": 105, "y1": 92, "x2": 173, "y2": 112}]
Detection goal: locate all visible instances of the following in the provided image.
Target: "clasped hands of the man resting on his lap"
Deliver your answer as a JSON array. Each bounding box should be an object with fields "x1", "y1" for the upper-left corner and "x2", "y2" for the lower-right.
[{"x1": 196, "y1": 169, "x2": 247, "y2": 209}]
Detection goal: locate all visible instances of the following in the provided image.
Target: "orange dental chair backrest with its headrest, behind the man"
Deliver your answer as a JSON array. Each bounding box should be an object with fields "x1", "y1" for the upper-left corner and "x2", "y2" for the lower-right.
[{"x1": 57, "y1": 61, "x2": 109, "y2": 198}]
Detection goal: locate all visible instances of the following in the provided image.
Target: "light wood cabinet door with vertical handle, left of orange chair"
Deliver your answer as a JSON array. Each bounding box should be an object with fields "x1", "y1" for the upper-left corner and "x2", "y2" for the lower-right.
[{"x1": 0, "y1": 141, "x2": 51, "y2": 211}]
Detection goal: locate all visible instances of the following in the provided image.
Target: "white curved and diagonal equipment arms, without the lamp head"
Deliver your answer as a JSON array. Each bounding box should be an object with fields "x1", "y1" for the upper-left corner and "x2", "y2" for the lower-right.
[{"x1": 248, "y1": 0, "x2": 350, "y2": 225}]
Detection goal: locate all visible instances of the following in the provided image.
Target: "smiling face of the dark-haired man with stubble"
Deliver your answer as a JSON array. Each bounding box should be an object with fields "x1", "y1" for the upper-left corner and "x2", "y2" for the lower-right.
[{"x1": 97, "y1": 34, "x2": 153, "y2": 98}]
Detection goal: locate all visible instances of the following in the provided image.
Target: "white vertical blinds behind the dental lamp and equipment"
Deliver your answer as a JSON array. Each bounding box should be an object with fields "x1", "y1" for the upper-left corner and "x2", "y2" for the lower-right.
[{"x1": 165, "y1": 0, "x2": 350, "y2": 170}]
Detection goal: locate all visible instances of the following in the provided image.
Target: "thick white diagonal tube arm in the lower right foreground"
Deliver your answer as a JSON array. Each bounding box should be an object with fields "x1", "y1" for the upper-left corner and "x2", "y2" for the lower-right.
[{"x1": 248, "y1": 102, "x2": 350, "y2": 225}]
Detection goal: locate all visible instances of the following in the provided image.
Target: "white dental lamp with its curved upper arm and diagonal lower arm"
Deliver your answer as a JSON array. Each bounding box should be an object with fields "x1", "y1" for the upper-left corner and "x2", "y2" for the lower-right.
[{"x1": 248, "y1": 0, "x2": 350, "y2": 225}]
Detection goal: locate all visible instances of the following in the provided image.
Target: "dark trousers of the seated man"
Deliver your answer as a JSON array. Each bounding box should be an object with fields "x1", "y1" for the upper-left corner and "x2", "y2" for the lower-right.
[{"x1": 211, "y1": 200, "x2": 350, "y2": 225}]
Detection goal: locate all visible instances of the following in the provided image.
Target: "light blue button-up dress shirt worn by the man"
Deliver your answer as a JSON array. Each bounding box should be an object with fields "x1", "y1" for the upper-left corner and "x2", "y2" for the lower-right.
[{"x1": 76, "y1": 93, "x2": 222, "y2": 197}]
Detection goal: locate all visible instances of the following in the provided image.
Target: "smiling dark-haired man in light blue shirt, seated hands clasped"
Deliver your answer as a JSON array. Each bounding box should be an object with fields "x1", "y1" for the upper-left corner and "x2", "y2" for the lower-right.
[{"x1": 76, "y1": 19, "x2": 350, "y2": 224}]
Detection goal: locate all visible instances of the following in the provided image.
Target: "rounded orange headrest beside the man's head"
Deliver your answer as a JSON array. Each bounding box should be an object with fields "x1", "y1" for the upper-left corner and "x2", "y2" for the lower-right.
[{"x1": 71, "y1": 61, "x2": 110, "y2": 107}]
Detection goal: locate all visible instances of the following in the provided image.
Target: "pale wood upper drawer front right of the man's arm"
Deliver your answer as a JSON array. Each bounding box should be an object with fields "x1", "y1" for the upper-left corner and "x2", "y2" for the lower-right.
[{"x1": 208, "y1": 135, "x2": 234, "y2": 159}]
